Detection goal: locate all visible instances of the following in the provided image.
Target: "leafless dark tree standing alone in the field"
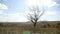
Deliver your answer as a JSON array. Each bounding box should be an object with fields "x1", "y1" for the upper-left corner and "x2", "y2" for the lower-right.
[{"x1": 28, "y1": 7, "x2": 44, "y2": 34}]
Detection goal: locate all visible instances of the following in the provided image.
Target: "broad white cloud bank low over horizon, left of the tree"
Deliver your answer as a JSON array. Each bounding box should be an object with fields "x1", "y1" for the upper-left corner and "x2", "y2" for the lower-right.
[{"x1": 0, "y1": 13, "x2": 27, "y2": 22}]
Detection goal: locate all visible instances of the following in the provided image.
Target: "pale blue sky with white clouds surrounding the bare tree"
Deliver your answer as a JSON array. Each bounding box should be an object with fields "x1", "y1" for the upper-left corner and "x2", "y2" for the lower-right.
[{"x1": 0, "y1": 0, "x2": 60, "y2": 22}]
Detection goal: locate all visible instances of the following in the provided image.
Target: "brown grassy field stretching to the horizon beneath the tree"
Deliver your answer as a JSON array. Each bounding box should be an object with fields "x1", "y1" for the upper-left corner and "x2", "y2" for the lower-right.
[{"x1": 0, "y1": 21, "x2": 60, "y2": 34}]
